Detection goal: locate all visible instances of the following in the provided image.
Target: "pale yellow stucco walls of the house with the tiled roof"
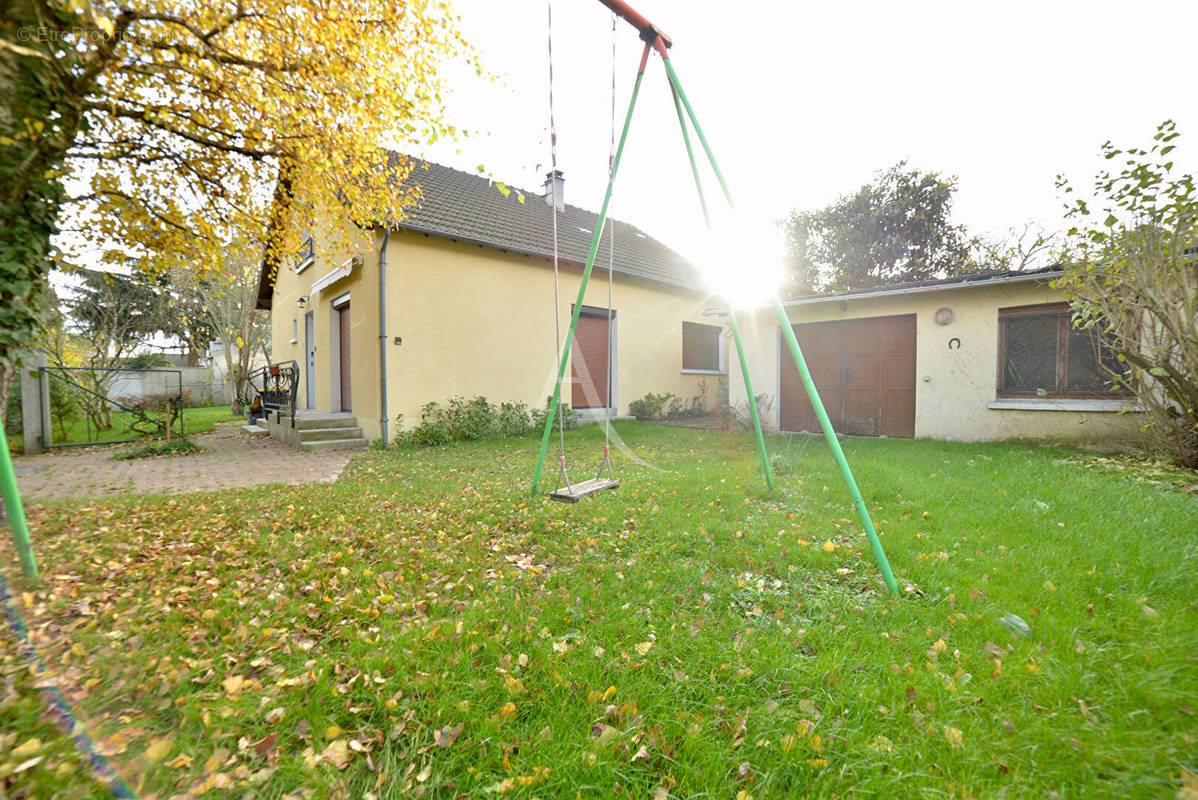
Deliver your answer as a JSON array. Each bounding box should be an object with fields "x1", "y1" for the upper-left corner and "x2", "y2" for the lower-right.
[{"x1": 272, "y1": 231, "x2": 727, "y2": 438}]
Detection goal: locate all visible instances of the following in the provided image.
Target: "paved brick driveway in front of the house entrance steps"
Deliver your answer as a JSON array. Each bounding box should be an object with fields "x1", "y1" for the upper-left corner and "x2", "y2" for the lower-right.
[{"x1": 13, "y1": 424, "x2": 355, "y2": 503}]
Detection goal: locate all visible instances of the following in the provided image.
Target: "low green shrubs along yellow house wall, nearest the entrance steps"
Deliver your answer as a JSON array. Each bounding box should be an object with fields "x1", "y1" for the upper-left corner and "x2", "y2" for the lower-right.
[{"x1": 395, "y1": 396, "x2": 579, "y2": 447}]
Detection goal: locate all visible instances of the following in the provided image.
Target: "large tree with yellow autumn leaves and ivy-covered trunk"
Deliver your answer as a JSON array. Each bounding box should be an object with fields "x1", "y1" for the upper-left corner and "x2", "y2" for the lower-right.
[{"x1": 0, "y1": 0, "x2": 477, "y2": 419}]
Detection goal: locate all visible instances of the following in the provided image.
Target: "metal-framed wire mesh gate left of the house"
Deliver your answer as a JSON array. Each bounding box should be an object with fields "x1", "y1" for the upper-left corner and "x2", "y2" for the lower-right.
[{"x1": 37, "y1": 366, "x2": 183, "y2": 448}]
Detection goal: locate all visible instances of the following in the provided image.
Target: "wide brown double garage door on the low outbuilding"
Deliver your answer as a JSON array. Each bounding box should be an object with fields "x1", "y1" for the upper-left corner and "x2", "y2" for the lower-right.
[{"x1": 780, "y1": 314, "x2": 915, "y2": 437}]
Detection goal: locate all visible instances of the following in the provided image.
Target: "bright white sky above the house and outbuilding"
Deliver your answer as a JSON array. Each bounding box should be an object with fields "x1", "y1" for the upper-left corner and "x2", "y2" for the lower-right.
[{"x1": 420, "y1": 0, "x2": 1198, "y2": 267}]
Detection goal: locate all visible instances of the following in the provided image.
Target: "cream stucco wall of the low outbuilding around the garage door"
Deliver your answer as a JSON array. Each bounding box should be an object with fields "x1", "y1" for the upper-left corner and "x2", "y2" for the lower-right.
[{"x1": 731, "y1": 281, "x2": 1142, "y2": 447}]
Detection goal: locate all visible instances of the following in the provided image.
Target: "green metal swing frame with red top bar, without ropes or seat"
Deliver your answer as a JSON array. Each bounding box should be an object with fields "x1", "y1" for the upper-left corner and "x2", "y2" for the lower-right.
[{"x1": 531, "y1": 0, "x2": 899, "y2": 595}]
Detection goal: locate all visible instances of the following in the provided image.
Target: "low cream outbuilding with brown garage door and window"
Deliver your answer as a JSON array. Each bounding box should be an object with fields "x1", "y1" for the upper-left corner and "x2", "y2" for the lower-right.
[{"x1": 731, "y1": 268, "x2": 1143, "y2": 446}]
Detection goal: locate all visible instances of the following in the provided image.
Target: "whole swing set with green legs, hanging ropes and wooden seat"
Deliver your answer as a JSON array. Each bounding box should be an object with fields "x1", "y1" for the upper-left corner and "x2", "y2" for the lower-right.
[{"x1": 531, "y1": 0, "x2": 899, "y2": 595}]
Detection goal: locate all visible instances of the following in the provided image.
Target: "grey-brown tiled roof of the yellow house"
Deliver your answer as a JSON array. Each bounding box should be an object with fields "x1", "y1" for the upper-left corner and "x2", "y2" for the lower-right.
[{"x1": 397, "y1": 155, "x2": 703, "y2": 291}]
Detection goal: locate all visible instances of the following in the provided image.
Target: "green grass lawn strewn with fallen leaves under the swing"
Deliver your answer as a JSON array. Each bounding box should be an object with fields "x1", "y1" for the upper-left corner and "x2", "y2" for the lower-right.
[{"x1": 0, "y1": 424, "x2": 1198, "y2": 800}]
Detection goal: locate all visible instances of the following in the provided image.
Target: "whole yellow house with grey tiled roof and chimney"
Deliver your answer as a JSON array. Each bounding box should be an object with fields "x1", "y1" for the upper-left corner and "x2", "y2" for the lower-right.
[{"x1": 259, "y1": 164, "x2": 727, "y2": 438}]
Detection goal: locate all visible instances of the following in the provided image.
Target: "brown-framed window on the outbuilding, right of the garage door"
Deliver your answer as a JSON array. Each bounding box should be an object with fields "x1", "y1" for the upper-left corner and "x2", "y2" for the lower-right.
[{"x1": 998, "y1": 303, "x2": 1127, "y2": 398}]
